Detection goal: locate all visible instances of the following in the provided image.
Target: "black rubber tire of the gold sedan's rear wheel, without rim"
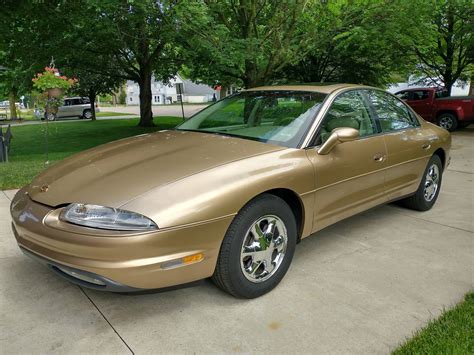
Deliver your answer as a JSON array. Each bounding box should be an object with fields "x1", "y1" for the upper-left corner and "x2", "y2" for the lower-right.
[{"x1": 401, "y1": 155, "x2": 443, "y2": 211}]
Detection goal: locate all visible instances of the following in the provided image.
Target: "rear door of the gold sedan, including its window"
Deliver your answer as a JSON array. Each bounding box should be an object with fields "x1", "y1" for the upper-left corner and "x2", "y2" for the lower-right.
[{"x1": 367, "y1": 90, "x2": 432, "y2": 200}]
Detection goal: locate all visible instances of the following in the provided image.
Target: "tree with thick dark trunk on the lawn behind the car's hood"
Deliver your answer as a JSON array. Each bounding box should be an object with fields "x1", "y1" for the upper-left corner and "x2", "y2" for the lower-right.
[{"x1": 70, "y1": 0, "x2": 185, "y2": 126}]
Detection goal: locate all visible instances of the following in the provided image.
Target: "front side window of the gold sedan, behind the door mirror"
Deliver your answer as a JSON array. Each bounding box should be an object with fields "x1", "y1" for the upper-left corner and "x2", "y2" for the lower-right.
[{"x1": 315, "y1": 91, "x2": 377, "y2": 145}]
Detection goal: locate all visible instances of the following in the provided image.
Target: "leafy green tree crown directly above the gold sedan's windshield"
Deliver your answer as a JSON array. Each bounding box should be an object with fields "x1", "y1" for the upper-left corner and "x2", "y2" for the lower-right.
[{"x1": 183, "y1": 0, "x2": 309, "y2": 88}]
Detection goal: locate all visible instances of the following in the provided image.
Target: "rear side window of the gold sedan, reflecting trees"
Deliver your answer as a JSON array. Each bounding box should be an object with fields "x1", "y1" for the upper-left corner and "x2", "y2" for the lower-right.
[{"x1": 368, "y1": 91, "x2": 419, "y2": 132}]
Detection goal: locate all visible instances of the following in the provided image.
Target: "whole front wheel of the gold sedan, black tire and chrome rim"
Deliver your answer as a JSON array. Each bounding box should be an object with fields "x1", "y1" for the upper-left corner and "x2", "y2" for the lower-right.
[{"x1": 212, "y1": 194, "x2": 297, "y2": 298}]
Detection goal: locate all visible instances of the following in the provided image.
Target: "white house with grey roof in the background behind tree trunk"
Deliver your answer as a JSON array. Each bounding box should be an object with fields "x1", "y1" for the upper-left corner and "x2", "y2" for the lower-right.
[{"x1": 126, "y1": 75, "x2": 219, "y2": 106}]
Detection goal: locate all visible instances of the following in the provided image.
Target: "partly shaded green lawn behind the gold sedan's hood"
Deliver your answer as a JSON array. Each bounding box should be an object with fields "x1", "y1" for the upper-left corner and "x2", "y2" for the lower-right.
[{"x1": 0, "y1": 116, "x2": 181, "y2": 190}]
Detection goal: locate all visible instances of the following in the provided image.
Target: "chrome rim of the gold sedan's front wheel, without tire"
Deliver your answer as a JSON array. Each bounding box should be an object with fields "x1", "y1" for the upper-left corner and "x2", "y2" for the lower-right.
[{"x1": 240, "y1": 215, "x2": 288, "y2": 283}]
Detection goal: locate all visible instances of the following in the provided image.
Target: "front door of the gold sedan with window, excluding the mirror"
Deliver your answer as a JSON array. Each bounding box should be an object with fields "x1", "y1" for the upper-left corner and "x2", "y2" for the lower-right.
[{"x1": 307, "y1": 90, "x2": 387, "y2": 232}]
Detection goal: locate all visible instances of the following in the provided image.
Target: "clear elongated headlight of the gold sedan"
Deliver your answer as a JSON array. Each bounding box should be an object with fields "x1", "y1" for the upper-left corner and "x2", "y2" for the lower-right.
[{"x1": 60, "y1": 203, "x2": 158, "y2": 231}]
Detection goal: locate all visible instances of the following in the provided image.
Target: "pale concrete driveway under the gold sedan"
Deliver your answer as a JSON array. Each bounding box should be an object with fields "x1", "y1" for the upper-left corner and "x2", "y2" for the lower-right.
[{"x1": 0, "y1": 126, "x2": 474, "y2": 354}]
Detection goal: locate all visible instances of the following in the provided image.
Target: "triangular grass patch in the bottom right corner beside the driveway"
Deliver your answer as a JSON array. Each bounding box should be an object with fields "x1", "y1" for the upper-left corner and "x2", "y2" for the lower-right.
[{"x1": 393, "y1": 292, "x2": 474, "y2": 355}]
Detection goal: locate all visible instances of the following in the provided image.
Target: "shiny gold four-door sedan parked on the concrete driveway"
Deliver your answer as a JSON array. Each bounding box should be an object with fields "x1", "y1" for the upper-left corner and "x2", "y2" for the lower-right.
[{"x1": 11, "y1": 85, "x2": 451, "y2": 298}]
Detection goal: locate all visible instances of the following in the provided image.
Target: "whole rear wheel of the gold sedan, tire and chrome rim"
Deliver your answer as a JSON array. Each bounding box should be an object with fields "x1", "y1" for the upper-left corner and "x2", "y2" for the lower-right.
[{"x1": 402, "y1": 155, "x2": 443, "y2": 211}]
